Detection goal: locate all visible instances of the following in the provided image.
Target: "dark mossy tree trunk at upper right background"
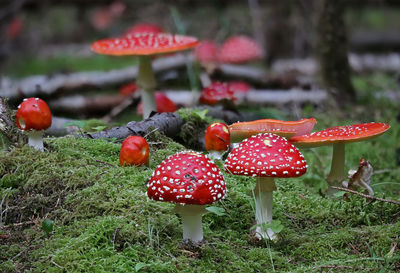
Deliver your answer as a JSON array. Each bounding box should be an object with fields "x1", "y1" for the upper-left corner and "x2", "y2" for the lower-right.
[{"x1": 317, "y1": 0, "x2": 356, "y2": 106}]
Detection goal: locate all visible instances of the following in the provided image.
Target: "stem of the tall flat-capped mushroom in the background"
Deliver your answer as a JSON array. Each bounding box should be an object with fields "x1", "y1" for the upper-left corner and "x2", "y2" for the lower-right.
[{"x1": 137, "y1": 56, "x2": 157, "y2": 118}]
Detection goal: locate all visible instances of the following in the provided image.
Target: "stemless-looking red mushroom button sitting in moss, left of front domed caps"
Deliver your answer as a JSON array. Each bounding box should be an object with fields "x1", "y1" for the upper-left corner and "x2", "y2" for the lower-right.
[{"x1": 119, "y1": 136, "x2": 149, "y2": 166}]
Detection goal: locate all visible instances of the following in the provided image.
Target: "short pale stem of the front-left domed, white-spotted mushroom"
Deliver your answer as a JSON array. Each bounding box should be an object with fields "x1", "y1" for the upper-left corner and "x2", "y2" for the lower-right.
[{"x1": 174, "y1": 204, "x2": 206, "y2": 243}]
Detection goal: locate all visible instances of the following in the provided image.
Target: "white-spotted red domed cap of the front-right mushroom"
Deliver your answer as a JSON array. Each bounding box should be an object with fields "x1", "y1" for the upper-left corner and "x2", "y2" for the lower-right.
[{"x1": 225, "y1": 134, "x2": 307, "y2": 177}]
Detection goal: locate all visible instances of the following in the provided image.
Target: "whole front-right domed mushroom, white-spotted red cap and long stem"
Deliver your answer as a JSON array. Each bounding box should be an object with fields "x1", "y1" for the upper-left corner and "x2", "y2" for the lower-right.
[{"x1": 225, "y1": 134, "x2": 307, "y2": 240}]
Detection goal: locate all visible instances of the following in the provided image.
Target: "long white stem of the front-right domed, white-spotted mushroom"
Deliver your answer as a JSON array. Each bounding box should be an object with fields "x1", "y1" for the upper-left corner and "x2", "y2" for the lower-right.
[{"x1": 254, "y1": 177, "x2": 276, "y2": 240}]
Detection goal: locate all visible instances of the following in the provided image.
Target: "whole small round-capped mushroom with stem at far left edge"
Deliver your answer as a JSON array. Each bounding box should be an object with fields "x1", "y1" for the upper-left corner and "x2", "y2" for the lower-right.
[{"x1": 16, "y1": 98, "x2": 51, "y2": 151}]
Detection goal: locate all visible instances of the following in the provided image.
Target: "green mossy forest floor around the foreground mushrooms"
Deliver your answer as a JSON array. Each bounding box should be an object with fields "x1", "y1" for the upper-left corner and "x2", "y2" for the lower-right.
[{"x1": 0, "y1": 76, "x2": 400, "y2": 272}]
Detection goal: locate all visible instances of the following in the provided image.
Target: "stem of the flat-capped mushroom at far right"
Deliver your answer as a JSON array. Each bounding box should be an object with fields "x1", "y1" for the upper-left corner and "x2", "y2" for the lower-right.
[{"x1": 326, "y1": 142, "x2": 346, "y2": 196}]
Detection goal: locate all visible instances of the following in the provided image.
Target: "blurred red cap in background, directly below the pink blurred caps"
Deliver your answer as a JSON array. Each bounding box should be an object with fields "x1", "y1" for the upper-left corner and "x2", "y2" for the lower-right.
[{"x1": 199, "y1": 82, "x2": 236, "y2": 105}]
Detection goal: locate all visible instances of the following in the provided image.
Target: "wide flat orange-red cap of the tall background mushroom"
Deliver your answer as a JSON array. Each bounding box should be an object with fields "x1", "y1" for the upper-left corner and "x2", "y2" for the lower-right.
[{"x1": 92, "y1": 33, "x2": 198, "y2": 56}]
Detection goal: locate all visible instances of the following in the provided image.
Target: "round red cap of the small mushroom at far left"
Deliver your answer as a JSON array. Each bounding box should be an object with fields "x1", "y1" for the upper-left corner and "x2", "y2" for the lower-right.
[{"x1": 16, "y1": 98, "x2": 51, "y2": 131}]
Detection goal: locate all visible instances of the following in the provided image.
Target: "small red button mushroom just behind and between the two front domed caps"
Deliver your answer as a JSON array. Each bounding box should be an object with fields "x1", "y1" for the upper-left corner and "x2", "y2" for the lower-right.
[{"x1": 204, "y1": 122, "x2": 230, "y2": 159}]
